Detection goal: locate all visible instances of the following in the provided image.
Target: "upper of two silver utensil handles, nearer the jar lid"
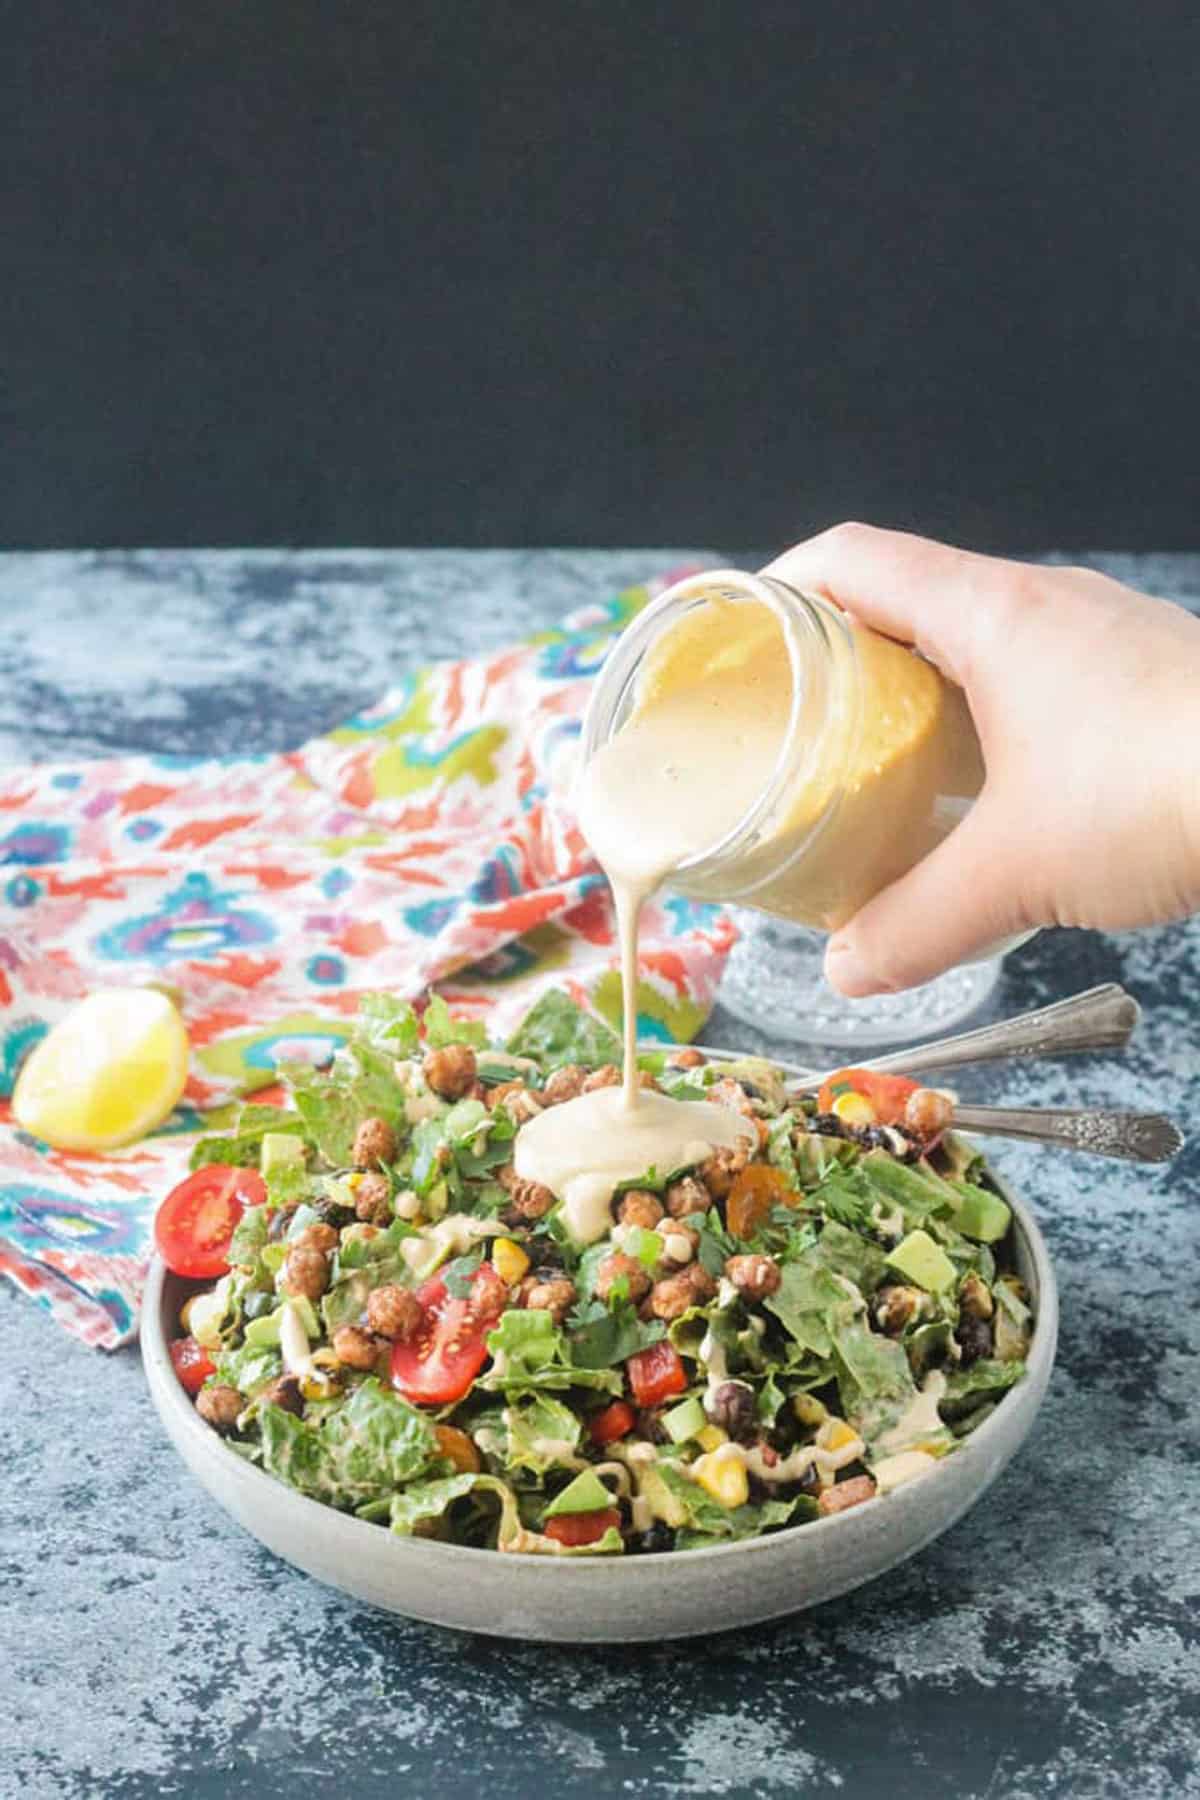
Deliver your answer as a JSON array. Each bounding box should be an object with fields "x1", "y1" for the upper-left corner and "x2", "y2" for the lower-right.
[{"x1": 788, "y1": 981, "x2": 1142, "y2": 1093}]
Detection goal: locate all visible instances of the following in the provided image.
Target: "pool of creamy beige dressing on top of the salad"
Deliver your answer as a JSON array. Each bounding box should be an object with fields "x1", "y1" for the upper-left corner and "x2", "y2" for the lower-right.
[{"x1": 513, "y1": 1087, "x2": 754, "y2": 1244}]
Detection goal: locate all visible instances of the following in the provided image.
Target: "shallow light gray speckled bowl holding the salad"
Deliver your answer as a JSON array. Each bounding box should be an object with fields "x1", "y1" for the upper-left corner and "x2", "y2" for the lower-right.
[{"x1": 142, "y1": 1080, "x2": 1058, "y2": 1643}]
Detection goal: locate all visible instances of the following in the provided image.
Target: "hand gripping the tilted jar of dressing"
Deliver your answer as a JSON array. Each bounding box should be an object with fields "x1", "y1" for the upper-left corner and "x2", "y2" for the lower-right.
[{"x1": 765, "y1": 526, "x2": 1200, "y2": 995}]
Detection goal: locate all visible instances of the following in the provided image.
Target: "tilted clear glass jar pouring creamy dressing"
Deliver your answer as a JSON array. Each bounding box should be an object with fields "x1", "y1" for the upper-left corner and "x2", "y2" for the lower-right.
[{"x1": 583, "y1": 569, "x2": 984, "y2": 931}]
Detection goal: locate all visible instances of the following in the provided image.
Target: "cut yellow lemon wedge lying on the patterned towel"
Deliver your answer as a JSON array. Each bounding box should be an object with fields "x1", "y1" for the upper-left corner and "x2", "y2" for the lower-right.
[{"x1": 13, "y1": 988, "x2": 189, "y2": 1150}]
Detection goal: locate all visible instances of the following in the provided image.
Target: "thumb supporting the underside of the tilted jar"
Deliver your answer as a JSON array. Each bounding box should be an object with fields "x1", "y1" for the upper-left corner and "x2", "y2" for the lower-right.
[{"x1": 826, "y1": 796, "x2": 1034, "y2": 999}]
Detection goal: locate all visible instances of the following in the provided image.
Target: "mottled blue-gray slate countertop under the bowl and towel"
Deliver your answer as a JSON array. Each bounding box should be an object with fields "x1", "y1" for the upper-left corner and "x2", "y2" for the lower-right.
[{"x1": 0, "y1": 551, "x2": 1200, "y2": 1800}]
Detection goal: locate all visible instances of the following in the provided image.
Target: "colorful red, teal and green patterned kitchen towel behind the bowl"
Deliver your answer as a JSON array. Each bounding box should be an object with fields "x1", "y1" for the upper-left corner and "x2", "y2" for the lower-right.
[{"x1": 0, "y1": 576, "x2": 732, "y2": 1348}]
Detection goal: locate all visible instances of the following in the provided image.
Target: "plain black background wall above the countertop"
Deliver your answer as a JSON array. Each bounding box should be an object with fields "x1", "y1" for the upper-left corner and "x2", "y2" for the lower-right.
[{"x1": 0, "y1": 0, "x2": 1200, "y2": 549}]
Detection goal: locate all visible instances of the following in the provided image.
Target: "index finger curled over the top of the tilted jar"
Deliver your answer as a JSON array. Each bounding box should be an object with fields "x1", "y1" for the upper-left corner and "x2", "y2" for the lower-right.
[{"x1": 763, "y1": 526, "x2": 1015, "y2": 686}]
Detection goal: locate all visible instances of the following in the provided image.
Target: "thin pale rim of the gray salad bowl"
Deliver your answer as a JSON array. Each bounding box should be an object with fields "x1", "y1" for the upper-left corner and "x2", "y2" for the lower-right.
[{"x1": 139, "y1": 1044, "x2": 1058, "y2": 1582}]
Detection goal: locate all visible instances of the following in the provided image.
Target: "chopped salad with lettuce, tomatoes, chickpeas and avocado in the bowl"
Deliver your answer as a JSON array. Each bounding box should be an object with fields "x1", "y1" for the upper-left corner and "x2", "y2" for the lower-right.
[{"x1": 157, "y1": 994, "x2": 1033, "y2": 1555}]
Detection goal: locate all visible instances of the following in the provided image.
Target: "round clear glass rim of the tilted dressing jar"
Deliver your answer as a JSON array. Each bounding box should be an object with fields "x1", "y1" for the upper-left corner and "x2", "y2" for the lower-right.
[{"x1": 581, "y1": 569, "x2": 849, "y2": 878}]
